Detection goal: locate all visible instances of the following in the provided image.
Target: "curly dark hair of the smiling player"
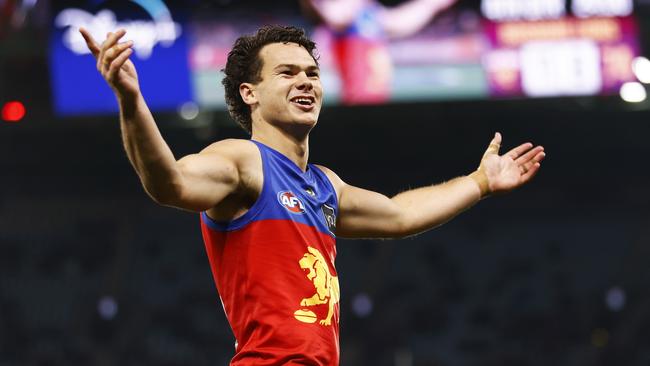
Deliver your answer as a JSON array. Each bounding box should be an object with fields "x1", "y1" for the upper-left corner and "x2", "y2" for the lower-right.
[{"x1": 221, "y1": 25, "x2": 318, "y2": 134}]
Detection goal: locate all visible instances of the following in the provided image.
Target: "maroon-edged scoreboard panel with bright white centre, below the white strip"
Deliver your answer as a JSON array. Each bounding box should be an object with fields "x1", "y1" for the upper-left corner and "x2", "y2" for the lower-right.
[{"x1": 484, "y1": 17, "x2": 640, "y2": 97}]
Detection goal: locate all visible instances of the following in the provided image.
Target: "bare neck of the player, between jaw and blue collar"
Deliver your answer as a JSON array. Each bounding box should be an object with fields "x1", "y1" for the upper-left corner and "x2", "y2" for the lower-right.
[{"x1": 251, "y1": 124, "x2": 309, "y2": 172}]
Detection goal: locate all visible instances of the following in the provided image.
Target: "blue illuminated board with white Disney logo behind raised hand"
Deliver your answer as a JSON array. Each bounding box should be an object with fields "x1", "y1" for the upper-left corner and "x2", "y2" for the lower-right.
[{"x1": 49, "y1": 0, "x2": 193, "y2": 115}]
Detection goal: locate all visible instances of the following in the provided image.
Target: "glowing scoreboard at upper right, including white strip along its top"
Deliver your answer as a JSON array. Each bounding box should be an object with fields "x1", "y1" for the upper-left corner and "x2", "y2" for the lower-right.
[{"x1": 482, "y1": 0, "x2": 641, "y2": 97}]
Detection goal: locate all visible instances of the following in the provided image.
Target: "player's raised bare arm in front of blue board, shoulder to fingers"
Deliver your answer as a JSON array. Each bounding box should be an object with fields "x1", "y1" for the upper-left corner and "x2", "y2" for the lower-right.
[{"x1": 79, "y1": 29, "x2": 239, "y2": 211}]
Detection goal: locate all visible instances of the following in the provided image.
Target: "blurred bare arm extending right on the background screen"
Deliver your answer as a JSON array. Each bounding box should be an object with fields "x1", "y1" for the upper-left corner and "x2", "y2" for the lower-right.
[{"x1": 379, "y1": 0, "x2": 456, "y2": 38}]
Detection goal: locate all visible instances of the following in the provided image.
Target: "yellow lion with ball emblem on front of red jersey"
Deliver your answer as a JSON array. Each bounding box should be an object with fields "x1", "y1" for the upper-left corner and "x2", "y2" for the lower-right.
[{"x1": 294, "y1": 247, "x2": 340, "y2": 325}]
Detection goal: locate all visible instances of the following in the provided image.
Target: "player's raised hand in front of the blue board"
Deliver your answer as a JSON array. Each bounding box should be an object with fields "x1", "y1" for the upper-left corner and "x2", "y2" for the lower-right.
[{"x1": 79, "y1": 28, "x2": 140, "y2": 100}]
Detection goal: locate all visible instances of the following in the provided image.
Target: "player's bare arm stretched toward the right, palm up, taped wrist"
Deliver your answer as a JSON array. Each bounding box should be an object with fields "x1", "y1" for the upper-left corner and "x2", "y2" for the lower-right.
[{"x1": 326, "y1": 133, "x2": 545, "y2": 238}]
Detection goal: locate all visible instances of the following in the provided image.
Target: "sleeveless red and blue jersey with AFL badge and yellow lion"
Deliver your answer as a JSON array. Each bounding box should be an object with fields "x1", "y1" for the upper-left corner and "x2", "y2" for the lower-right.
[{"x1": 201, "y1": 141, "x2": 340, "y2": 366}]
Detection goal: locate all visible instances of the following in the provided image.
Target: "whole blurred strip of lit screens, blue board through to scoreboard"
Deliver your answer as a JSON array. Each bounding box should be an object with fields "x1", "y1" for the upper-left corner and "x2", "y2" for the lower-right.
[{"x1": 50, "y1": 0, "x2": 640, "y2": 115}]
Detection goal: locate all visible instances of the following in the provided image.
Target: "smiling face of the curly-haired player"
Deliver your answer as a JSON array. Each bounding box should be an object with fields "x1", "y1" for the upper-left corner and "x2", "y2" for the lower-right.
[{"x1": 252, "y1": 43, "x2": 323, "y2": 132}]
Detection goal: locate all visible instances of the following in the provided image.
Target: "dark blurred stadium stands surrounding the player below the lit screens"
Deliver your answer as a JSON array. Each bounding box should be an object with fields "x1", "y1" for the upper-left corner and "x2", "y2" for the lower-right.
[{"x1": 0, "y1": 1, "x2": 650, "y2": 366}]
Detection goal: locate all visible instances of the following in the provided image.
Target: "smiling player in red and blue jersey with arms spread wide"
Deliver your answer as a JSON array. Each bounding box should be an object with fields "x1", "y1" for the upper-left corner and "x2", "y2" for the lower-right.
[{"x1": 80, "y1": 26, "x2": 544, "y2": 365}]
